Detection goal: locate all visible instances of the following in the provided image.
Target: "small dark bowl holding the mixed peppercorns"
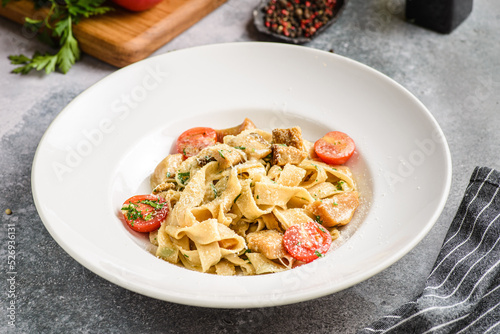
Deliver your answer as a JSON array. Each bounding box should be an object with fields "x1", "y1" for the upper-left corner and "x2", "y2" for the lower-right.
[{"x1": 253, "y1": 0, "x2": 348, "y2": 44}]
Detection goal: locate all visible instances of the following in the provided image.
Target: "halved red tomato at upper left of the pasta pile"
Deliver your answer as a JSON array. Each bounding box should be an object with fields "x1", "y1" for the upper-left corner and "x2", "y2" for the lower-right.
[{"x1": 177, "y1": 128, "x2": 217, "y2": 158}]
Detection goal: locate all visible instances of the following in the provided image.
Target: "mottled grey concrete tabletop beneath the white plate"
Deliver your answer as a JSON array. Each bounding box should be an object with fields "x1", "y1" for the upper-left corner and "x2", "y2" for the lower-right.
[{"x1": 0, "y1": 0, "x2": 500, "y2": 333}]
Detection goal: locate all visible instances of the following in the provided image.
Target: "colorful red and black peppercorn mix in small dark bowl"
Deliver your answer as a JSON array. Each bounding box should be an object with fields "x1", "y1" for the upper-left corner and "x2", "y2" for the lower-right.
[{"x1": 263, "y1": 0, "x2": 337, "y2": 38}]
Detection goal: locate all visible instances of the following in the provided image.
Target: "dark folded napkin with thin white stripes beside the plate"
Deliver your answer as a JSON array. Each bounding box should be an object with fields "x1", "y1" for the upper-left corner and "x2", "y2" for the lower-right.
[{"x1": 357, "y1": 167, "x2": 500, "y2": 334}]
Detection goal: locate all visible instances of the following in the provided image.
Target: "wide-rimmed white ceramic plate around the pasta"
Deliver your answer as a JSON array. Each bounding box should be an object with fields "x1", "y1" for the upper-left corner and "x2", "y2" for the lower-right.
[{"x1": 32, "y1": 43, "x2": 451, "y2": 308}]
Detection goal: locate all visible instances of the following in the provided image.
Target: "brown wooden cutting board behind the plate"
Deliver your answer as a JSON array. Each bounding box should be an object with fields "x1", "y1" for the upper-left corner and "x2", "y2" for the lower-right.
[{"x1": 0, "y1": 0, "x2": 227, "y2": 67}]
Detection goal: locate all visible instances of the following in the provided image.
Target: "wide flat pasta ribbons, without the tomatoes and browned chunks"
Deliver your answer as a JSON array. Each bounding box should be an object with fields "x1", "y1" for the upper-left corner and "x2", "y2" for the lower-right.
[{"x1": 150, "y1": 129, "x2": 362, "y2": 275}]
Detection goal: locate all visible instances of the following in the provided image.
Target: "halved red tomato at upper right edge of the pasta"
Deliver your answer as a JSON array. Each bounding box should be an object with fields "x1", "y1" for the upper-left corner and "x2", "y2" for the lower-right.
[{"x1": 314, "y1": 131, "x2": 356, "y2": 165}]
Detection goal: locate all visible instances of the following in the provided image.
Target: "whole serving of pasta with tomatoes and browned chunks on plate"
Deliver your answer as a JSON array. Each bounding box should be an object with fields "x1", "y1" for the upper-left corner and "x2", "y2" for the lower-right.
[{"x1": 121, "y1": 119, "x2": 359, "y2": 275}]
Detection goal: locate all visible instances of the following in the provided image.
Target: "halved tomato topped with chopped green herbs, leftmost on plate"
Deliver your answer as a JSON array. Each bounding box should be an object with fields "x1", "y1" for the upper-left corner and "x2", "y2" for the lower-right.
[{"x1": 121, "y1": 195, "x2": 168, "y2": 232}]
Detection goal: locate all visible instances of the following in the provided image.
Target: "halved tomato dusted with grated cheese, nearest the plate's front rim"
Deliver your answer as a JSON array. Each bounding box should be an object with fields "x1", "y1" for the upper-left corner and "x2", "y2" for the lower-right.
[{"x1": 283, "y1": 221, "x2": 332, "y2": 263}]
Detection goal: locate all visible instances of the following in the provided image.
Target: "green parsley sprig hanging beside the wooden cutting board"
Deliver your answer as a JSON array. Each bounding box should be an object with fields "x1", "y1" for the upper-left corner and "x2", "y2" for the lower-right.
[{"x1": 2, "y1": 0, "x2": 112, "y2": 74}]
